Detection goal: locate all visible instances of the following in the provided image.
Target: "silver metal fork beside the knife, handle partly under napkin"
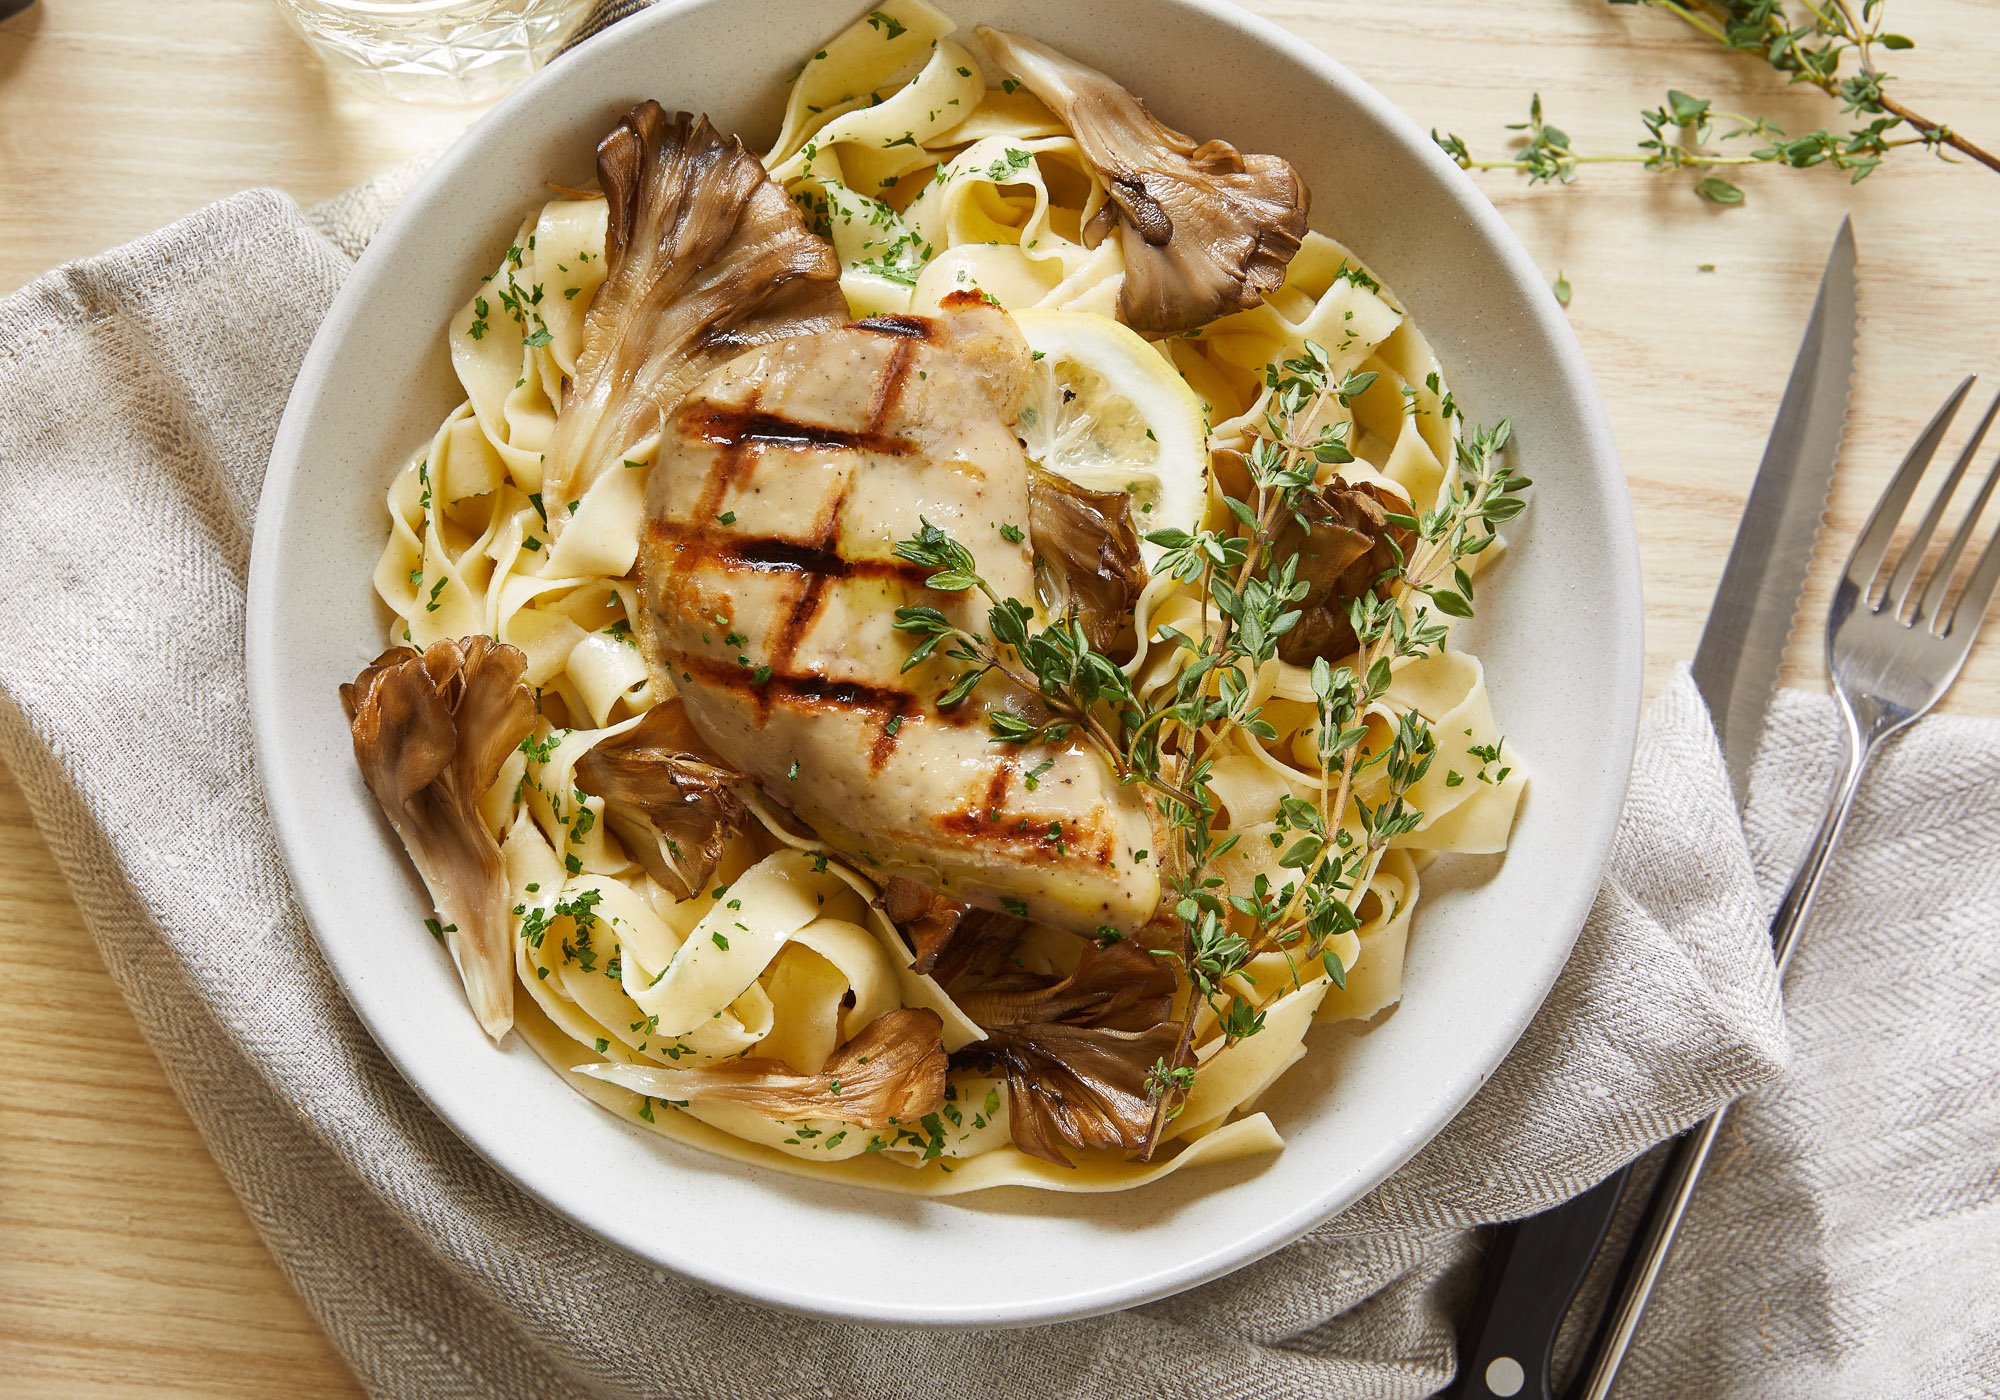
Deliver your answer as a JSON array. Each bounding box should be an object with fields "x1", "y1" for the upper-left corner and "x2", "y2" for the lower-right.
[{"x1": 1570, "y1": 376, "x2": 2000, "y2": 1400}]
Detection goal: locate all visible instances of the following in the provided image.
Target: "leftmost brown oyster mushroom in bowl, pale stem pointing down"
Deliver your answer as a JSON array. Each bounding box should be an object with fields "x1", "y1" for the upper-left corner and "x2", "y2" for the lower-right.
[{"x1": 340, "y1": 636, "x2": 534, "y2": 1040}]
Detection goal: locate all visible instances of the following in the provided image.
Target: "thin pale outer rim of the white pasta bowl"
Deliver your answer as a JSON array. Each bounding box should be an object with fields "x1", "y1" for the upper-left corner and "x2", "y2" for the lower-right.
[{"x1": 244, "y1": 0, "x2": 1644, "y2": 1328}]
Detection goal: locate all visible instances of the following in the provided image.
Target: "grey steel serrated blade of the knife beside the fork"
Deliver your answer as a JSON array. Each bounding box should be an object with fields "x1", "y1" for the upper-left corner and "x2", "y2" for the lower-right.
[{"x1": 1694, "y1": 218, "x2": 1860, "y2": 808}]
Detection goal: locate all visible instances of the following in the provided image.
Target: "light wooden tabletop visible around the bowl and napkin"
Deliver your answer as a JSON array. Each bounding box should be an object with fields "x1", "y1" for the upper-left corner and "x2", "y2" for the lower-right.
[{"x1": 0, "y1": 0, "x2": 2000, "y2": 1398}]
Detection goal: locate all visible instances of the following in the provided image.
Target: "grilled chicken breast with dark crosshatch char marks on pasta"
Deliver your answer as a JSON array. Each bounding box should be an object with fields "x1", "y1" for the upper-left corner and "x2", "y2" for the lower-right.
[{"x1": 624, "y1": 294, "x2": 1160, "y2": 934}]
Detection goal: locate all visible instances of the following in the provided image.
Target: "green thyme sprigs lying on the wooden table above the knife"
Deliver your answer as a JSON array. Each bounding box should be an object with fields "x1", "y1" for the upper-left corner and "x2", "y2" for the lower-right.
[{"x1": 1430, "y1": 0, "x2": 2000, "y2": 204}]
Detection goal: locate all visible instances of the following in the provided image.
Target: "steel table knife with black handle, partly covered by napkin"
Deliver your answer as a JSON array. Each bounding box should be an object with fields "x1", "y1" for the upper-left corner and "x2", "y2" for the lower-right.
[{"x1": 1450, "y1": 220, "x2": 1858, "y2": 1400}]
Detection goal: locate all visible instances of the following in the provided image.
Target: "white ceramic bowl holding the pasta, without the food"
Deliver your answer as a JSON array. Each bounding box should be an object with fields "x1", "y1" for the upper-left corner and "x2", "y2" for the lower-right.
[{"x1": 248, "y1": 0, "x2": 1640, "y2": 1324}]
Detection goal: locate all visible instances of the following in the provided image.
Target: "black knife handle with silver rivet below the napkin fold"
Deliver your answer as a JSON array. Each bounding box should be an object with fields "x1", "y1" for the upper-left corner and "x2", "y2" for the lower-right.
[{"x1": 1448, "y1": 1166, "x2": 1632, "y2": 1400}]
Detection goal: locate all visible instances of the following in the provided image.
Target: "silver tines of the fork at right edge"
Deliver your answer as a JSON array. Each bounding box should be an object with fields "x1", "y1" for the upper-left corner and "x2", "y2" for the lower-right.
[{"x1": 1844, "y1": 376, "x2": 2000, "y2": 640}]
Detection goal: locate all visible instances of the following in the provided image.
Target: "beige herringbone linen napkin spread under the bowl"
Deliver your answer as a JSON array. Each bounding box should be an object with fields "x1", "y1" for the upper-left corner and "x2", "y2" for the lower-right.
[{"x1": 0, "y1": 188, "x2": 2000, "y2": 1400}]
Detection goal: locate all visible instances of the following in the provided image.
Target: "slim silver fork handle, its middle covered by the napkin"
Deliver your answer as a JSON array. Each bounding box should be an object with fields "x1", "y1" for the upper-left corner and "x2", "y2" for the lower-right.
[{"x1": 1570, "y1": 732, "x2": 1872, "y2": 1400}]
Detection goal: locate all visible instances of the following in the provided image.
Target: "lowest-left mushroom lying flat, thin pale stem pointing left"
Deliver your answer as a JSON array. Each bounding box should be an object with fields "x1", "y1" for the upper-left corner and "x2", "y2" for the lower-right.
[{"x1": 576, "y1": 1008, "x2": 948, "y2": 1128}]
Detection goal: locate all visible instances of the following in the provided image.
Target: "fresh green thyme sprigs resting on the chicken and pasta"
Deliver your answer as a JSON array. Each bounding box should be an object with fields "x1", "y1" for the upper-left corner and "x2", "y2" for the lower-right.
[{"x1": 896, "y1": 342, "x2": 1530, "y2": 1158}]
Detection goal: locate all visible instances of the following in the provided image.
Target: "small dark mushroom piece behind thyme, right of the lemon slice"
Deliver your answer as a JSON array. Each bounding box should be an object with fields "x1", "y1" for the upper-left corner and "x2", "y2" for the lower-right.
[{"x1": 1272, "y1": 476, "x2": 1410, "y2": 666}]
